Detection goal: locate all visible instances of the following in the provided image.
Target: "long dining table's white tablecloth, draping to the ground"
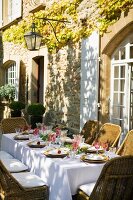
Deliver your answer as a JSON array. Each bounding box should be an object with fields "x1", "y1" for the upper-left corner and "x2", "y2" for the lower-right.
[{"x1": 1, "y1": 133, "x2": 114, "y2": 200}]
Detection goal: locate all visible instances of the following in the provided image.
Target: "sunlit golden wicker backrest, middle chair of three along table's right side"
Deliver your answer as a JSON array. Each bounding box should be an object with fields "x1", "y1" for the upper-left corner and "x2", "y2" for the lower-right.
[{"x1": 96, "y1": 123, "x2": 121, "y2": 147}]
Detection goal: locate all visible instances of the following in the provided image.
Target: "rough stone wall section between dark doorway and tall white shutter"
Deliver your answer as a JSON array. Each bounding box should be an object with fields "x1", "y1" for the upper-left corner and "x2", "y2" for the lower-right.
[{"x1": 46, "y1": 44, "x2": 81, "y2": 129}]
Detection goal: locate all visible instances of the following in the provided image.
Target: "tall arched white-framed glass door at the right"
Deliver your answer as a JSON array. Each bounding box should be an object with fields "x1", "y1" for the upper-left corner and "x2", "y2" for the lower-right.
[{"x1": 110, "y1": 34, "x2": 133, "y2": 133}]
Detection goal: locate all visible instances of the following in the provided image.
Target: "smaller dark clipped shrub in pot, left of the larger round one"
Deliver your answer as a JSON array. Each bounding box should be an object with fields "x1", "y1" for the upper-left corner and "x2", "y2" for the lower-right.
[{"x1": 9, "y1": 101, "x2": 25, "y2": 117}]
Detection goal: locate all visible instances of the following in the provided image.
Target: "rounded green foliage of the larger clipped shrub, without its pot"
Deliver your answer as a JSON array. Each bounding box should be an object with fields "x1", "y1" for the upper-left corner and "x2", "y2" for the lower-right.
[{"x1": 27, "y1": 103, "x2": 45, "y2": 116}]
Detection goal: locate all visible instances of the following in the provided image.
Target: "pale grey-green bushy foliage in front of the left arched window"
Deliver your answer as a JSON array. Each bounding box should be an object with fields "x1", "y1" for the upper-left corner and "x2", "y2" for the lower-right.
[{"x1": 0, "y1": 84, "x2": 16, "y2": 100}]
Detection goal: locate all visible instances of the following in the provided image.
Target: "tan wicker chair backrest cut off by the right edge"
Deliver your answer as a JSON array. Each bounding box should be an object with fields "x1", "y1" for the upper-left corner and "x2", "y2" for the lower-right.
[{"x1": 116, "y1": 130, "x2": 133, "y2": 156}]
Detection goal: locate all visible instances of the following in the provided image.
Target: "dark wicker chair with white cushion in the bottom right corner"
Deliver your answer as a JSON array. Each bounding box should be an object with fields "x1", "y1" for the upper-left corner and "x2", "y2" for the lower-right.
[{"x1": 77, "y1": 156, "x2": 133, "y2": 200}]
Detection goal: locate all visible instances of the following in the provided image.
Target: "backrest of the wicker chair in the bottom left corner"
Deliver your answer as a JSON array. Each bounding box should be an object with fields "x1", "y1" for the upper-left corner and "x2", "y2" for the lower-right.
[{"x1": 0, "y1": 160, "x2": 24, "y2": 193}]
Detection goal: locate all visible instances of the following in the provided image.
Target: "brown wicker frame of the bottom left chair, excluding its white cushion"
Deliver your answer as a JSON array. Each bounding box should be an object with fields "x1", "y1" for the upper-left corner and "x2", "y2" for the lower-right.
[{"x1": 0, "y1": 161, "x2": 49, "y2": 200}]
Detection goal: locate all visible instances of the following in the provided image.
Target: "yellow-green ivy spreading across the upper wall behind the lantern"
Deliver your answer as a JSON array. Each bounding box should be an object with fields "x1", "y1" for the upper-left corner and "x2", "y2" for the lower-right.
[{"x1": 3, "y1": 0, "x2": 133, "y2": 52}]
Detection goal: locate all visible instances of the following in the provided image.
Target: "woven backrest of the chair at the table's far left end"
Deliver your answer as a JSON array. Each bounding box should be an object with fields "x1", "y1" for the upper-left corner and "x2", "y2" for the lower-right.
[{"x1": 1, "y1": 117, "x2": 28, "y2": 133}]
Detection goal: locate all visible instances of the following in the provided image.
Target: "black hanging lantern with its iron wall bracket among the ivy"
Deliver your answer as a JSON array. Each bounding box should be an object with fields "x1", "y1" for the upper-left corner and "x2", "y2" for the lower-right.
[{"x1": 24, "y1": 18, "x2": 70, "y2": 51}]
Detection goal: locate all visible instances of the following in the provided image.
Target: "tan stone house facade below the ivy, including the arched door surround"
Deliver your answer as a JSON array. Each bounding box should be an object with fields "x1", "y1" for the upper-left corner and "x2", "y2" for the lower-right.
[{"x1": 0, "y1": 0, "x2": 133, "y2": 133}]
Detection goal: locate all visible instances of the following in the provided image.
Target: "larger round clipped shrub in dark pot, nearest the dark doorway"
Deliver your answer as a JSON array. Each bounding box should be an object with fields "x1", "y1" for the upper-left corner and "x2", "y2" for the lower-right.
[{"x1": 27, "y1": 103, "x2": 46, "y2": 128}]
